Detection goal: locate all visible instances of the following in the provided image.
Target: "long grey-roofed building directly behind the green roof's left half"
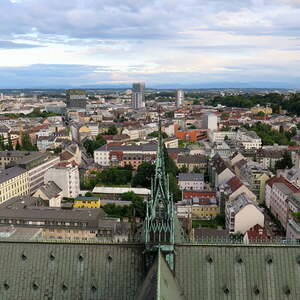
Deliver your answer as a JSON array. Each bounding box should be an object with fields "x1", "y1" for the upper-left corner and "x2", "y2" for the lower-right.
[{"x1": 0, "y1": 196, "x2": 118, "y2": 241}]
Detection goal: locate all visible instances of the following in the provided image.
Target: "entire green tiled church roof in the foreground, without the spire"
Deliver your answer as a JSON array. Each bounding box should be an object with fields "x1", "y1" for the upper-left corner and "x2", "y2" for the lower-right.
[{"x1": 0, "y1": 240, "x2": 300, "y2": 300}]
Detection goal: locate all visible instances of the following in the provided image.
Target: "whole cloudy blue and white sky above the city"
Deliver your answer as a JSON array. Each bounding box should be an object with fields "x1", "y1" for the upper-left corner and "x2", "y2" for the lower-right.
[{"x1": 0, "y1": 0, "x2": 300, "y2": 88}]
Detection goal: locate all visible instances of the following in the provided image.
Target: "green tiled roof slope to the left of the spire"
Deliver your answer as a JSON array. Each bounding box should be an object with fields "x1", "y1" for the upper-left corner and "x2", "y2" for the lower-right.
[{"x1": 0, "y1": 242, "x2": 144, "y2": 300}]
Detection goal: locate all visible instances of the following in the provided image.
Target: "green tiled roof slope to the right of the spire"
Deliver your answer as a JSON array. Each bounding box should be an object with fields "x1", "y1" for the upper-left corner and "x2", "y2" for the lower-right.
[{"x1": 175, "y1": 245, "x2": 300, "y2": 300}]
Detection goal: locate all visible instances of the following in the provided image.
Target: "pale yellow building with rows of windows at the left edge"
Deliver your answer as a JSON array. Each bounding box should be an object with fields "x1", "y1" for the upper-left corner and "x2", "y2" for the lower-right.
[{"x1": 0, "y1": 166, "x2": 30, "y2": 203}]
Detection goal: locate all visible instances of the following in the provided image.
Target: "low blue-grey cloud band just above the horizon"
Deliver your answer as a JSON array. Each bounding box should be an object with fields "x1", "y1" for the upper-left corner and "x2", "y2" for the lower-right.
[{"x1": 0, "y1": 65, "x2": 300, "y2": 88}]
